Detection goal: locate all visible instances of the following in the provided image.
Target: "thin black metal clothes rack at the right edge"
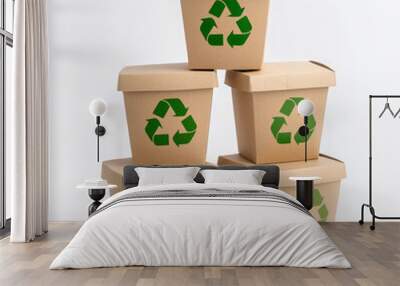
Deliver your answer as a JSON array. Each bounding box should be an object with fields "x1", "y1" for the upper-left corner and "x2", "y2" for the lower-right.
[{"x1": 358, "y1": 95, "x2": 400, "y2": 230}]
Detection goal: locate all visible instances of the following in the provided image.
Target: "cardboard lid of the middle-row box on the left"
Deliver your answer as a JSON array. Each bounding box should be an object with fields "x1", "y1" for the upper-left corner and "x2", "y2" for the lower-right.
[{"x1": 118, "y1": 64, "x2": 218, "y2": 91}]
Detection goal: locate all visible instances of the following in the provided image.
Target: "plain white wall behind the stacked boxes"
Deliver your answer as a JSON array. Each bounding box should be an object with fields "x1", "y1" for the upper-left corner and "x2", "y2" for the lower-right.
[{"x1": 48, "y1": 0, "x2": 400, "y2": 220}]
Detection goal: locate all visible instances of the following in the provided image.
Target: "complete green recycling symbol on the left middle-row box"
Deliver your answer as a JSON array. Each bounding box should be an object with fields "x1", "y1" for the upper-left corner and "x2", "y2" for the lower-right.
[{"x1": 145, "y1": 98, "x2": 197, "y2": 147}]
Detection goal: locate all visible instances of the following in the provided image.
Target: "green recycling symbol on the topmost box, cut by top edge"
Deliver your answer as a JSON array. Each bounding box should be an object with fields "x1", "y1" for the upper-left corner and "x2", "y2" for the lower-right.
[{"x1": 200, "y1": 0, "x2": 253, "y2": 48}]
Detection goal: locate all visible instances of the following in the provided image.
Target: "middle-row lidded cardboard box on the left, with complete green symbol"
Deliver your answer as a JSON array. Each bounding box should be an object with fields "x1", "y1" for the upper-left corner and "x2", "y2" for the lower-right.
[{"x1": 118, "y1": 64, "x2": 218, "y2": 165}]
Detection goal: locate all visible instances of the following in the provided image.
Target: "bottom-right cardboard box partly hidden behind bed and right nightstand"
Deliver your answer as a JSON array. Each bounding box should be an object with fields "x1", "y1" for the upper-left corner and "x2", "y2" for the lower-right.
[{"x1": 218, "y1": 154, "x2": 346, "y2": 221}]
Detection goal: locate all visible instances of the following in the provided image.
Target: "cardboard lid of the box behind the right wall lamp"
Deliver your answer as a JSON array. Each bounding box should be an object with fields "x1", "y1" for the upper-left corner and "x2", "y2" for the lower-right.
[{"x1": 225, "y1": 61, "x2": 336, "y2": 92}]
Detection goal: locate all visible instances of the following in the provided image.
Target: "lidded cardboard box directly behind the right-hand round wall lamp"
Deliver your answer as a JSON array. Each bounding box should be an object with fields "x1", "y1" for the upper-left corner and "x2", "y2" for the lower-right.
[{"x1": 225, "y1": 62, "x2": 335, "y2": 164}]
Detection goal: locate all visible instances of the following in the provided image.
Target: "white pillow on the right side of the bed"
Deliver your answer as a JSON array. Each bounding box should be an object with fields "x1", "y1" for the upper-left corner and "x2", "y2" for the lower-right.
[{"x1": 200, "y1": 170, "x2": 265, "y2": 185}]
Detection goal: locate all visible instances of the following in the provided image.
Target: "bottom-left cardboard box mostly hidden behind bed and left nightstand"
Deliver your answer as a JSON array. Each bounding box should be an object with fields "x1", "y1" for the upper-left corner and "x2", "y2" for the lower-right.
[{"x1": 101, "y1": 158, "x2": 214, "y2": 195}]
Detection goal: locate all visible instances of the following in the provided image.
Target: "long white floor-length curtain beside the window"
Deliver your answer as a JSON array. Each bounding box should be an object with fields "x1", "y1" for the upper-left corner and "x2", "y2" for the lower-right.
[{"x1": 6, "y1": 0, "x2": 48, "y2": 242}]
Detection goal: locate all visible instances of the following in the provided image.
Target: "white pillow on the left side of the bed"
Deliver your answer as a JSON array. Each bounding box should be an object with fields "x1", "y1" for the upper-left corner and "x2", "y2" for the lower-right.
[{"x1": 135, "y1": 167, "x2": 200, "y2": 186}]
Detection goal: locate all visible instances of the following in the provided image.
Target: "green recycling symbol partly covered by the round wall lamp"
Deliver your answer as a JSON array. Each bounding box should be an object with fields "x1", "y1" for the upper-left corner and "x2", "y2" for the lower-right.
[{"x1": 271, "y1": 97, "x2": 317, "y2": 144}]
